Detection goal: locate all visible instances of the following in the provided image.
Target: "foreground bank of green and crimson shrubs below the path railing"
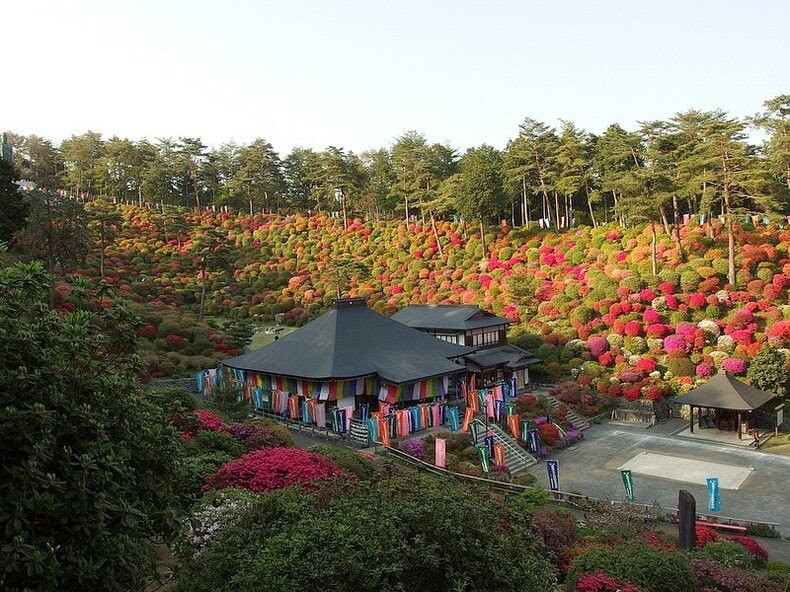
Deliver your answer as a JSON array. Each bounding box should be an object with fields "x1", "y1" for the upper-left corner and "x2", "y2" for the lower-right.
[{"x1": 172, "y1": 400, "x2": 789, "y2": 592}]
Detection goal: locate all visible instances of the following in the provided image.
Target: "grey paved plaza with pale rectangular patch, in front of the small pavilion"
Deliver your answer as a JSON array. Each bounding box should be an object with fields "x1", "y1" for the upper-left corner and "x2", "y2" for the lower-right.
[{"x1": 529, "y1": 420, "x2": 790, "y2": 536}]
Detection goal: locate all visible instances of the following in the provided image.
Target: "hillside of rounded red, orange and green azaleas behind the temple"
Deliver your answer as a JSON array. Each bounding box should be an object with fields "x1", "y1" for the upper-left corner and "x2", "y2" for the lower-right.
[{"x1": 69, "y1": 206, "x2": 790, "y2": 400}]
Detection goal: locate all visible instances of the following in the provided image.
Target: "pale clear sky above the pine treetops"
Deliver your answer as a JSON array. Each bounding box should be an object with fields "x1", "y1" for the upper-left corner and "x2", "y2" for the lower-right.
[{"x1": 0, "y1": 0, "x2": 790, "y2": 155}]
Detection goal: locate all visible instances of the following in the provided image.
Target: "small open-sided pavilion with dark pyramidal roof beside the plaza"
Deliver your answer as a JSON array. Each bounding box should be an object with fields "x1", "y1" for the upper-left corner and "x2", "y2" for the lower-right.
[{"x1": 677, "y1": 370, "x2": 776, "y2": 439}]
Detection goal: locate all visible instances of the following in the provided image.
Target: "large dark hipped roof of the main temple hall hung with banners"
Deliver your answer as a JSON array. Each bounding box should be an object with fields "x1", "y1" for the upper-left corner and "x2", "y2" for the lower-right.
[{"x1": 223, "y1": 298, "x2": 472, "y2": 384}]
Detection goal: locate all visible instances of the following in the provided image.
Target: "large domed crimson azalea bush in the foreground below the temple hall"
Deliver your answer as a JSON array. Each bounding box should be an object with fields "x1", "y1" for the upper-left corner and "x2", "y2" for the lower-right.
[{"x1": 203, "y1": 448, "x2": 345, "y2": 493}]
